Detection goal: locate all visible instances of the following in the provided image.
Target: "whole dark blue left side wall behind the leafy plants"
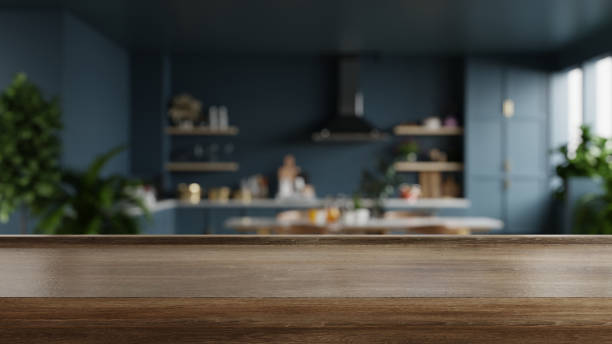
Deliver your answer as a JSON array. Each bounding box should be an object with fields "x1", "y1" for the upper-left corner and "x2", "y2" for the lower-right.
[{"x1": 0, "y1": 10, "x2": 130, "y2": 234}]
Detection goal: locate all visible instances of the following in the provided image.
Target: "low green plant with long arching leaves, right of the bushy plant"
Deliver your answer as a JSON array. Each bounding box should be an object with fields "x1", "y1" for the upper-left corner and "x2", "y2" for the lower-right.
[{"x1": 37, "y1": 147, "x2": 150, "y2": 234}]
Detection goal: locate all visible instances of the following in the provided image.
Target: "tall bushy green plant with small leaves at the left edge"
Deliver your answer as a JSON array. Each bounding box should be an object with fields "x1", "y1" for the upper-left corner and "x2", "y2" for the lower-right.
[{"x1": 0, "y1": 73, "x2": 62, "y2": 234}]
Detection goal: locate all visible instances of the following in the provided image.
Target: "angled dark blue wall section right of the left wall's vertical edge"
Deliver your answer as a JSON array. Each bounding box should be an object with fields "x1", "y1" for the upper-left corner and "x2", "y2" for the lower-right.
[{"x1": 61, "y1": 13, "x2": 130, "y2": 174}]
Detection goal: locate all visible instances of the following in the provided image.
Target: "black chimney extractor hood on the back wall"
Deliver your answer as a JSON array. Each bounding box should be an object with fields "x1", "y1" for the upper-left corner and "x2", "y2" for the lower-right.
[{"x1": 312, "y1": 57, "x2": 387, "y2": 142}]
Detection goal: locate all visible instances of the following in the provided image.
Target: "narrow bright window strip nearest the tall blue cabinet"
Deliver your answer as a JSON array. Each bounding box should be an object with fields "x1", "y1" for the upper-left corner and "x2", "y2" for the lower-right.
[{"x1": 567, "y1": 68, "x2": 583, "y2": 155}]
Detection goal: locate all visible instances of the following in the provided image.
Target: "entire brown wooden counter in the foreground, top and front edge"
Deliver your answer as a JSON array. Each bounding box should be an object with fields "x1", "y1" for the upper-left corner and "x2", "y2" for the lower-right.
[{"x1": 0, "y1": 236, "x2": 612, "y2": 343}]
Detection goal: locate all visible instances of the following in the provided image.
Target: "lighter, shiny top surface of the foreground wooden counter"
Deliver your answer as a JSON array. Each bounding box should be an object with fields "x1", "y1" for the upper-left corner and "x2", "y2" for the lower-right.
[{"x1": 0, "y1": 236, "x2": 612, "y2": 297}]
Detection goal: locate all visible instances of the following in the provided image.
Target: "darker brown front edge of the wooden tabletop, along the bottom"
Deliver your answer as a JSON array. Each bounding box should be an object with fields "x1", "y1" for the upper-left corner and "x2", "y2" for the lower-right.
[{"x1": 0, "y1": 298, "x2": 612, "y2": 344}]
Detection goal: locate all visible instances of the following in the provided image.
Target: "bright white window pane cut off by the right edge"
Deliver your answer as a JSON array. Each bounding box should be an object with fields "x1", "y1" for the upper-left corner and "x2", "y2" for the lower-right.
[{"x1": 595, "y1": 57, "x2": 612, "y2": 138}]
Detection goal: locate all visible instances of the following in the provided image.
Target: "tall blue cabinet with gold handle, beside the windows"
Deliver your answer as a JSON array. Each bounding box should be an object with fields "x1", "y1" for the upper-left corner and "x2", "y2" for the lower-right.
[{"x1": 465, "y1": 59, "x2": 550, "y2": 234}]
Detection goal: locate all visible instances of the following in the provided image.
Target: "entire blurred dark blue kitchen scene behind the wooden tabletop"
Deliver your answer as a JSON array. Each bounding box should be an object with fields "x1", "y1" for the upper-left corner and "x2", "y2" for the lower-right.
[{"x1": 0, "y1": 0, "x2": 612, "y2": 234}]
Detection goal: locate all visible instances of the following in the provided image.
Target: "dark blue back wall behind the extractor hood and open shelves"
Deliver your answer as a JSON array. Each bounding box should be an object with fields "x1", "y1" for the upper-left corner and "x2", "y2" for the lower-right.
[{"x1": 171, "y1": 56, "x2": 463, "y2": 195}]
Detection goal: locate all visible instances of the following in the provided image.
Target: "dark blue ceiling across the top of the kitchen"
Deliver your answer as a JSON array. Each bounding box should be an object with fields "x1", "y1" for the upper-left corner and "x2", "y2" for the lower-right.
[{"x1": 0, "y1": 0, "x2": 612, "y2": 54}]
